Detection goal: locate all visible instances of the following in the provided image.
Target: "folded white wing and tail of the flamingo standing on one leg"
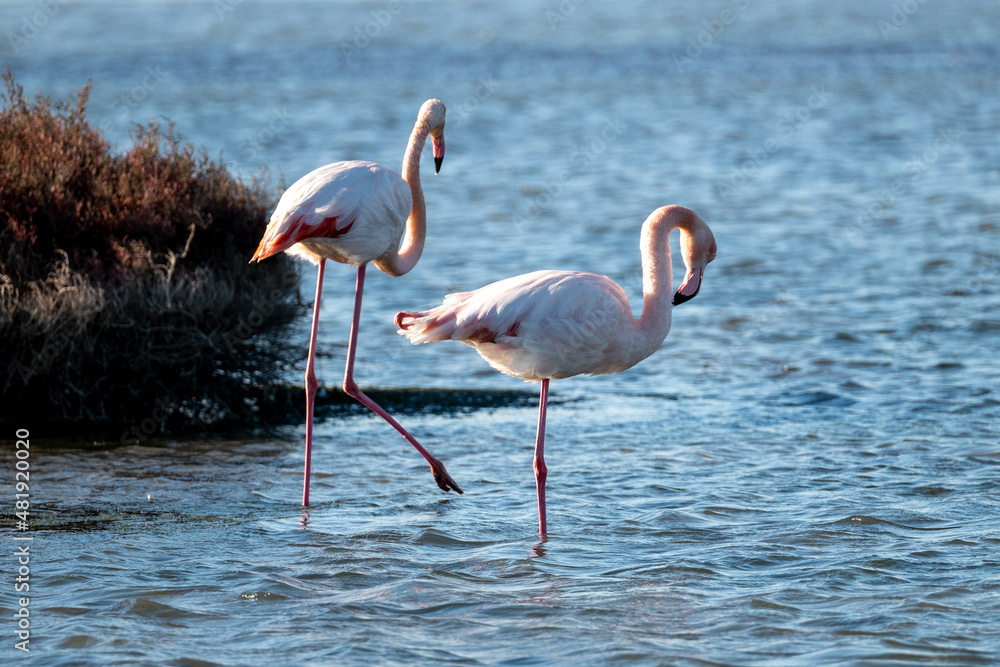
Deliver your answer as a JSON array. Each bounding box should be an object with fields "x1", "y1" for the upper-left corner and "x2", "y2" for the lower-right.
[{"x1": 396, "y1": 271, "x2": 634, "y2": 380}]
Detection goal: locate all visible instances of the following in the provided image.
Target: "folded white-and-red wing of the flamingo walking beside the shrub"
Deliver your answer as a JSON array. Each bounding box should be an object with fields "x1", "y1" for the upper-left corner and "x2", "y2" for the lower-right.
[{"x1": 251, "y1": 161, "x2": 412, "y2": 263}]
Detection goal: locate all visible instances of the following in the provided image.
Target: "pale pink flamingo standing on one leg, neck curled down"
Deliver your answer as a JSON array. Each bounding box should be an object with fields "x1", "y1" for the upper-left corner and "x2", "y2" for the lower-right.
[{"x1": 395, "y1": 206, "x2": 716, "y2": 535}]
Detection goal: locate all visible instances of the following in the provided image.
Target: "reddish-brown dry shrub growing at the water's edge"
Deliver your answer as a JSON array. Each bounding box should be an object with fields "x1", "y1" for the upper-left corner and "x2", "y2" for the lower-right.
[{"x1": 0, "y1": 71, "x2": 303, "y2": 437}]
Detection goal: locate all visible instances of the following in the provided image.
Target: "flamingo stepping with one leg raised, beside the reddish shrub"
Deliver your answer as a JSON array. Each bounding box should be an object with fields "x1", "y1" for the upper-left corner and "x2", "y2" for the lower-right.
[{"x1": 250, "y1": 99, "x2": 462, "y2": 507}]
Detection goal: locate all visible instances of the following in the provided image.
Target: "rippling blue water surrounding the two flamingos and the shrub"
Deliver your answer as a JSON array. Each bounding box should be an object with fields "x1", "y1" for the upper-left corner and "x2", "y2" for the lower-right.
[{"x1": 0, "y1": 0, "x2": 1000, "y2": 665}]
